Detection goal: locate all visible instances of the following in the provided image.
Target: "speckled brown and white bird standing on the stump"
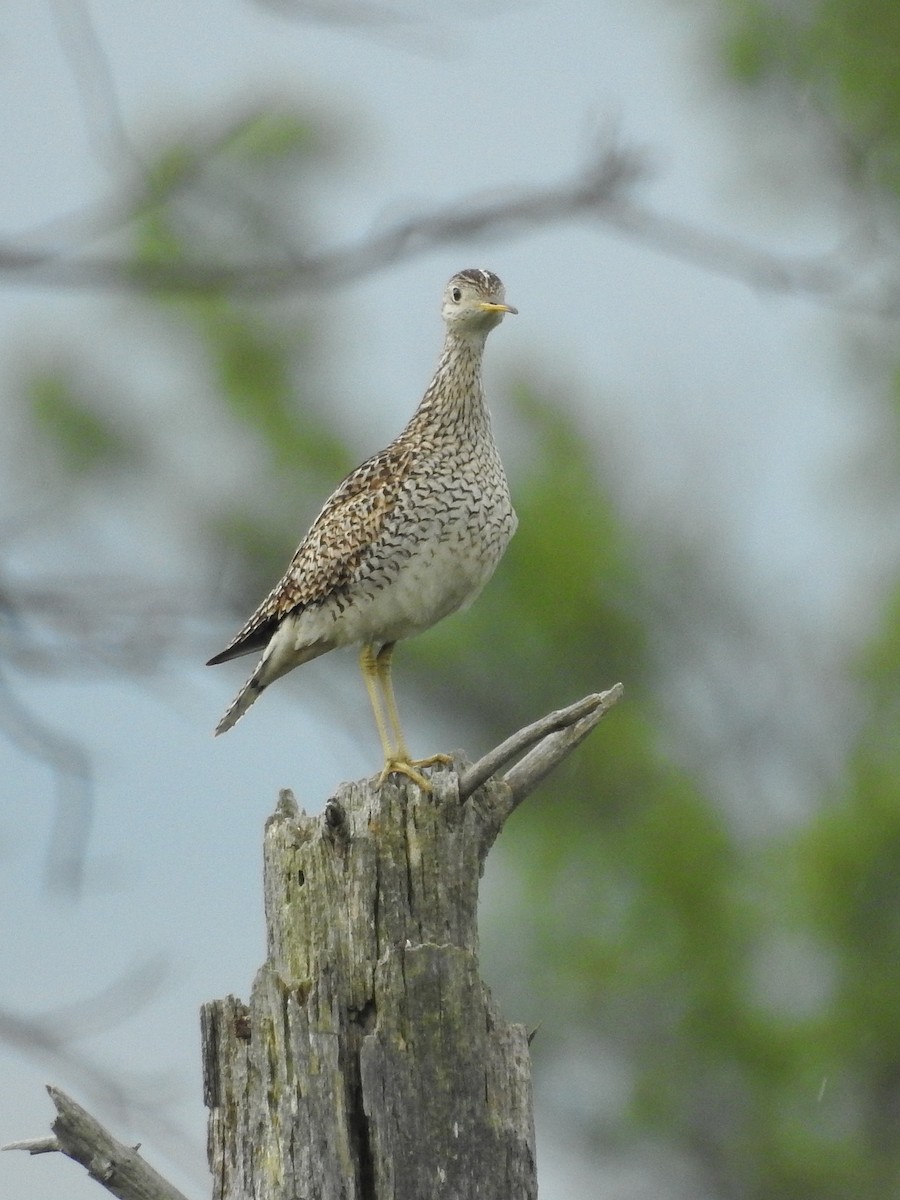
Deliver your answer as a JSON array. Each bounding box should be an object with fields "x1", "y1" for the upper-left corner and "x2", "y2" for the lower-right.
[{"x1": 206, "y1": 268, "x2": 517, "y2": 791}]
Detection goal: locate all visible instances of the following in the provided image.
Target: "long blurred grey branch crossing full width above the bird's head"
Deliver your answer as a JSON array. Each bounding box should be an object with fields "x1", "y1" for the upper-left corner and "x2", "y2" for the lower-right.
[{"x1": 0, "y1": 139, "x2": 900, "y2": 317}]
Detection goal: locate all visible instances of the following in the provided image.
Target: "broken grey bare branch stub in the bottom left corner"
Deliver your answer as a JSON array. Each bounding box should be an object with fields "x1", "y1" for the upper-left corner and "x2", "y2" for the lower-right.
[{"x1": 4, "y1": 1086, "x2": 192, "y2": 1200}]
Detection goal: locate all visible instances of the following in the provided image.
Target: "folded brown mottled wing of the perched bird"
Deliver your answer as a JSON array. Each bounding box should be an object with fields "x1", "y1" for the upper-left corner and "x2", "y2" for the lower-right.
[{"x1": 206, "y1": 443, "x2": 412, "y2": 666}]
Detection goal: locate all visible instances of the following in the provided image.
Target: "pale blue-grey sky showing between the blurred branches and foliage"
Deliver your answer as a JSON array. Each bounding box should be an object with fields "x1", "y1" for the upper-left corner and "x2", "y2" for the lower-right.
[{"x1": 0, "y1": 0, "x2": 880, "y2": 1200}]
